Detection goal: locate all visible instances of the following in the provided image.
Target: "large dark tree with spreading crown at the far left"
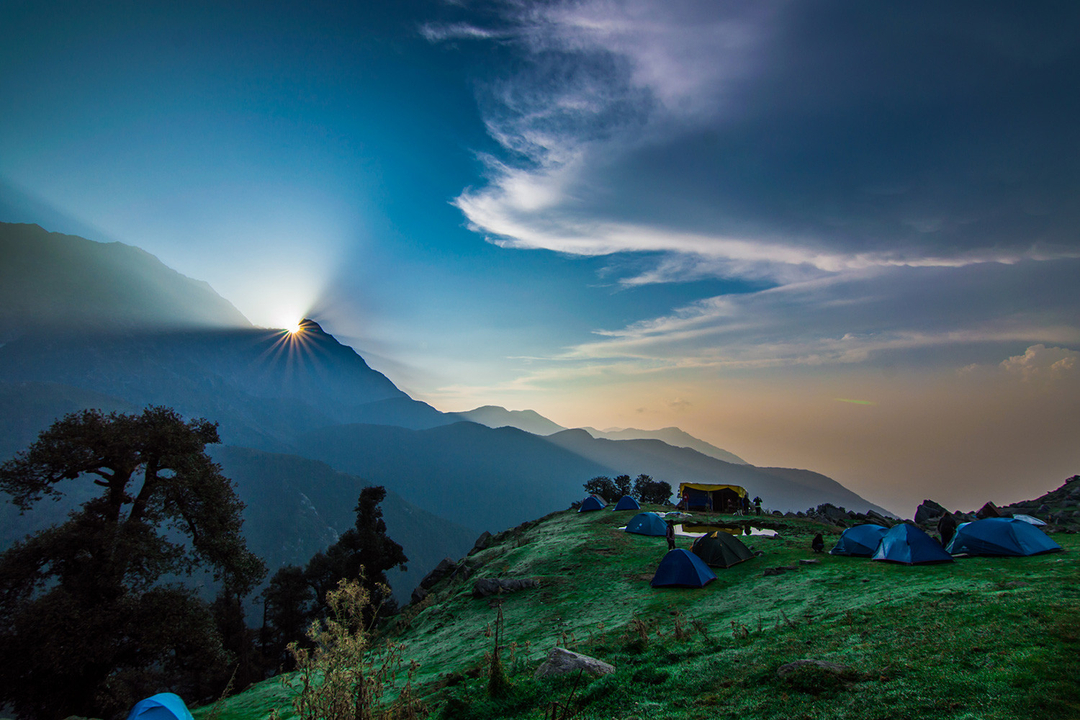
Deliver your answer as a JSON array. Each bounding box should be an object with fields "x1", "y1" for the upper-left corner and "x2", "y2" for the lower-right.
[{"x1": 0, "y1": 407, "x2": 265, "y2": 718}]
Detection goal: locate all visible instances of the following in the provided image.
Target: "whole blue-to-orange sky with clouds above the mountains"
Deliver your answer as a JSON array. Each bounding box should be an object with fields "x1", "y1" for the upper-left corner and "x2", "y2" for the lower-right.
[{"x1": 0, "y1": 0, "x2": 1080, "y2": 515}]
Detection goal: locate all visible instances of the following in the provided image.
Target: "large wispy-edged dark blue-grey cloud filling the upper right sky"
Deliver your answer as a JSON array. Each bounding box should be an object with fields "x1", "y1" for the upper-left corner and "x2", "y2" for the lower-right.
[{"x1": 429, "y1": 0, "x2": 1080, "y2": 285}]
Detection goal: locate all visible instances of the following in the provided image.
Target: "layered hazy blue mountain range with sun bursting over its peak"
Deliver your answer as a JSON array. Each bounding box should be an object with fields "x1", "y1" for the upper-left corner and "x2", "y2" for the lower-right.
[{"x1": 0, "y1": 223, "x2": 882, "y2": 596}]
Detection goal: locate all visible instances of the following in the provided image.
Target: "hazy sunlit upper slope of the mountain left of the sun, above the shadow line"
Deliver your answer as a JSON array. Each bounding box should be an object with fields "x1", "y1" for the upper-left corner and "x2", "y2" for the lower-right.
[{"x1": 0, "y1": 222, "x2": 251, "y2": 342}]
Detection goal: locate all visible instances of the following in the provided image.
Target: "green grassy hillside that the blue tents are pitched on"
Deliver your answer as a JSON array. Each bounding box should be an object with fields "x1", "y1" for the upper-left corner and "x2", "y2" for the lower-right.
[{"x1": 195, "y1": 512, "x2": 1080, "y2": 720}]
